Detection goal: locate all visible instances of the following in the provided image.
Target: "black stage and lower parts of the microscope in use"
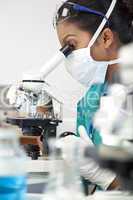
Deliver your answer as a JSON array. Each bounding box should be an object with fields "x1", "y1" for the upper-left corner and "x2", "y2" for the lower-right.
[{"x1": 7, "y1": 118, "x2": 62, "y2": 160}]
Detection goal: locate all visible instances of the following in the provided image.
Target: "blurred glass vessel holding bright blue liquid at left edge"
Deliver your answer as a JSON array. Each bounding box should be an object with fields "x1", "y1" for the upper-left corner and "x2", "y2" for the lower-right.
[{"x1": 0, "y1": 93, "x2": 27, "y2": 200}]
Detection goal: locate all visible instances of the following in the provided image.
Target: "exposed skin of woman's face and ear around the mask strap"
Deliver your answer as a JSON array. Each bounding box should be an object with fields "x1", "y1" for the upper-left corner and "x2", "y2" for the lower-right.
[{"x1": 57, "y1": 21, "x2": 118, "y2": 61}]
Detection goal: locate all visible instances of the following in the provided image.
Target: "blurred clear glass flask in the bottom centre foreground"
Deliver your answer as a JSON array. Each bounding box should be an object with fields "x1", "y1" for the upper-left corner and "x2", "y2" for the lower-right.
[{"x1": 44, "y1": 138, "x2": 85, "y2": 200}]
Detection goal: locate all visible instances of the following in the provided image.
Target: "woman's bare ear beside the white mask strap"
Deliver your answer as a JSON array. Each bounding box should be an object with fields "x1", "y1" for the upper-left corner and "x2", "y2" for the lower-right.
[{"x1": 98, "y1": 28, "x2": 114, "y2": 49}]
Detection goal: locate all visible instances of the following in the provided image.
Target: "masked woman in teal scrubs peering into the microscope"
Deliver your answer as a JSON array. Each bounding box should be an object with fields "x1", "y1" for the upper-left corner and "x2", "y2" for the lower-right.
[{"x1": 56, "y1": 0, "x2": 133, "y2": 189}]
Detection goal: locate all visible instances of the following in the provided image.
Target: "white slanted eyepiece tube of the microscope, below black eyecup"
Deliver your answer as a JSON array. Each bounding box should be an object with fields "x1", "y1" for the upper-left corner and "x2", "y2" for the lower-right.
[{"x1": 40, "y1": 51, "x2": 65, "y2": 79}]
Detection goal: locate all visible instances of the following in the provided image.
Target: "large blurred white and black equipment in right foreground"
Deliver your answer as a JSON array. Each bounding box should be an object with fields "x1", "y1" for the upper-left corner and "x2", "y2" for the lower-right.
[{"x1": 95, "y1": 44, "x2": 133, "y2": 191}]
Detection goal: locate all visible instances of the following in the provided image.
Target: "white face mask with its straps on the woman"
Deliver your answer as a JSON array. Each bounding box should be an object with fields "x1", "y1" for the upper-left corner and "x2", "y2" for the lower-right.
[{"x1": 65, "y1": 0, "x2": 120, "y2": 87}]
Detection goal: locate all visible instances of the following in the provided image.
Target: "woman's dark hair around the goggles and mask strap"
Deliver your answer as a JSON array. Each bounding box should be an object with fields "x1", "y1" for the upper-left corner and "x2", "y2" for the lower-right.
[{"x1": 56, "y1": 0, "x2": 133, "y2": 44}]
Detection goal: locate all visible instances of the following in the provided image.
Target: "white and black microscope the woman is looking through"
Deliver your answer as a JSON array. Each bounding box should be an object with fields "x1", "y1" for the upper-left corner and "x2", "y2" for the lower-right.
[{"x1": 7, "y1": 45, "x2": 73, "y2": 160}]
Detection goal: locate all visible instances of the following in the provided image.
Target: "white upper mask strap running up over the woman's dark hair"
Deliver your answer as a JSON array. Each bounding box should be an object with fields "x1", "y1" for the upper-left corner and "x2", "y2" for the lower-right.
[{"x1": 87, "y1": 0, "x2": 117, "y2": 49}]
